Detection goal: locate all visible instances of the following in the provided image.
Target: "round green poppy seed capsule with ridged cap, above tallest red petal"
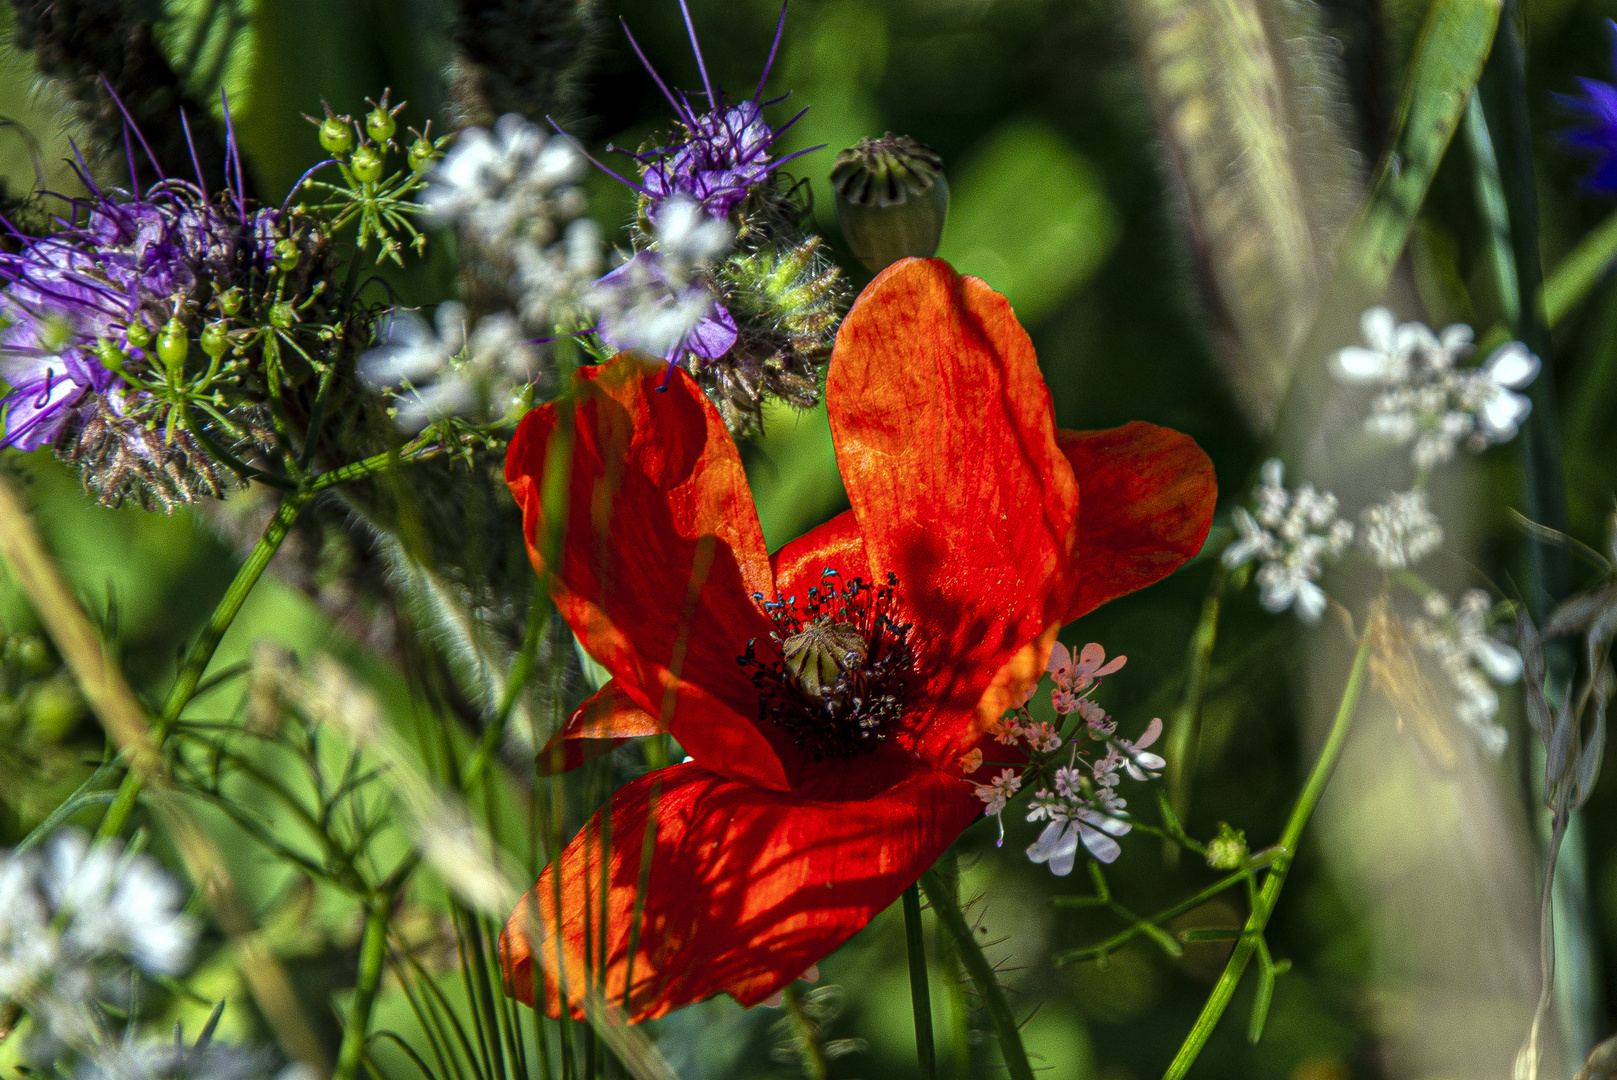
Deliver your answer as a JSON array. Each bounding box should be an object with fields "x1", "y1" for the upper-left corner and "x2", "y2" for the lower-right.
[{"x1": 831, "y1": 131, "x2": 949, "y2": 272}]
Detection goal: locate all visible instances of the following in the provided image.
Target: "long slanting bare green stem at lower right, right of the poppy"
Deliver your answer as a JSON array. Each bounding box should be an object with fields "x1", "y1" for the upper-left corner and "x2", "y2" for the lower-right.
[{"x1": 1163, "y1": 634, "x2": 1371, "y2": 1080}]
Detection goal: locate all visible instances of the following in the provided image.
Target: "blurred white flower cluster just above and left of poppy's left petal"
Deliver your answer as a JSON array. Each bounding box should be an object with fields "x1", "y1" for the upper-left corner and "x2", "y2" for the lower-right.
[{"x1": 359, "y1": 301, "x2": 540, "y2": 433}]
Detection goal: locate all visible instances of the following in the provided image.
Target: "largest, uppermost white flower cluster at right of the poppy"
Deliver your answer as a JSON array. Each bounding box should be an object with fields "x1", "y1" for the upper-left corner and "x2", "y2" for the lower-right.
[{"x1": 1331, "y1": 307, "x2": 1539, "y2": 470}]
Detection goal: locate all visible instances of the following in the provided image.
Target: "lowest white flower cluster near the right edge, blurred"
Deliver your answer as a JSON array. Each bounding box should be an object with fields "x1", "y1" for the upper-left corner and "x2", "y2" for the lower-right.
[{"x1": 1410, "y1": 589, "x2": 1522, "y2": 753}]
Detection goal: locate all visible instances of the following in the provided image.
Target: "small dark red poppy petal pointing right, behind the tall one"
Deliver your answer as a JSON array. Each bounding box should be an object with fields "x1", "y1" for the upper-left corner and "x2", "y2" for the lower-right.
[{"x1": 1058, "y1": 420, "x2": 1218, "y2": 624}]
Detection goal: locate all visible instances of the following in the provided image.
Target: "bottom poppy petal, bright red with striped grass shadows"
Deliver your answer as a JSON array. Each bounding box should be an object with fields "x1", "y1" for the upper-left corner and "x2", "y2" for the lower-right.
[{"x1": 501, "y1": 752, "x2": 983, "y2": 1020}]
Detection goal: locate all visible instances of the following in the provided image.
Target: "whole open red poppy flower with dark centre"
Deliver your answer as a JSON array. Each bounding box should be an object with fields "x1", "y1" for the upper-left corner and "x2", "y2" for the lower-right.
[{"x1": 503, "y1": 259, "x2": 1214, "y2": 1020}]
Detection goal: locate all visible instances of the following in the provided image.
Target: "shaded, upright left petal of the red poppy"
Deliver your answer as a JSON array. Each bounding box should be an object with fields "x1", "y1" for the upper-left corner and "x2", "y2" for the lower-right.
[{"x1": 506, "y1": 354, "x2": 791, "y2": 787}]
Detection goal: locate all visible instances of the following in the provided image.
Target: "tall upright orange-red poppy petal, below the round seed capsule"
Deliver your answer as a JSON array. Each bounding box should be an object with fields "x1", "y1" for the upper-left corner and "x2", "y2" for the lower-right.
[{"x1": 826, "y1": 259, "x2": 1079, "y2": 716}]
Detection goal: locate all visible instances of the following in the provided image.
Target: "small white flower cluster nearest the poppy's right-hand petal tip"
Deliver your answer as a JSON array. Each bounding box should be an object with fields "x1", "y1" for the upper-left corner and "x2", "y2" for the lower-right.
[{"x1": 1224, "y1": 458, "x2": 1353, "y2": 622}]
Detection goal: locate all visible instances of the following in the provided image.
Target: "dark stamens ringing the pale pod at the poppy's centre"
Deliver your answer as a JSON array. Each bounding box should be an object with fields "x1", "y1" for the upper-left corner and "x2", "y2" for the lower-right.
[{"x1": 736, "y1": 569, "x2": 915, "y2": 761}]
